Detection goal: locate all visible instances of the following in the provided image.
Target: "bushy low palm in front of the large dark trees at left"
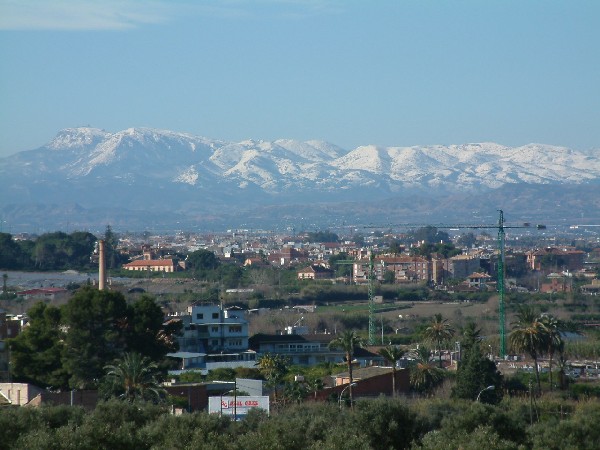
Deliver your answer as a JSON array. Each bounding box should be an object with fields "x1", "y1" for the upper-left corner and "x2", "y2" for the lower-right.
[{"x1": 104, "y1": 353, "x2": 165, "y2": 402}]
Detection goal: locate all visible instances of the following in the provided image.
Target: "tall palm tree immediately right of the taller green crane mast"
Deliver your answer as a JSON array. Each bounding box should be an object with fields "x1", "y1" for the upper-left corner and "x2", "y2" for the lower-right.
[{"x1": 508, "y1": 306, "x2": 548, "y2": 393}]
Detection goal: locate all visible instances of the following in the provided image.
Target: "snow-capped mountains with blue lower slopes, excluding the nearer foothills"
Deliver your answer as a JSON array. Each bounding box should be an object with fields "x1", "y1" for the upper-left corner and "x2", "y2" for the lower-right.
[{"x1": 0, "y1": 128, "x2": 600, "y2": 230}]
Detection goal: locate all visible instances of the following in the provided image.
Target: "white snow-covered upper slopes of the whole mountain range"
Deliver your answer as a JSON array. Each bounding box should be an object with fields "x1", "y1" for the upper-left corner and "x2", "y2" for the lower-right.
[{"x1": 0, "y1": 128, "x2": 600, "y2": 199}]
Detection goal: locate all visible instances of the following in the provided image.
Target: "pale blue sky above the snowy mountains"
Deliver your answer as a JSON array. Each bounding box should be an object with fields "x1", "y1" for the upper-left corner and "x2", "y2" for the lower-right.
[{"x1": 0, "y1": 0, "x2": 600, "y2": 156}]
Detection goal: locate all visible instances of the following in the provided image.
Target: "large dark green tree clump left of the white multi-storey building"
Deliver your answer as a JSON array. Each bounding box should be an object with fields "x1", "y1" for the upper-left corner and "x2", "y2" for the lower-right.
[{"x1": 9, "y1": 287, "x2": 180, "y2": 389}]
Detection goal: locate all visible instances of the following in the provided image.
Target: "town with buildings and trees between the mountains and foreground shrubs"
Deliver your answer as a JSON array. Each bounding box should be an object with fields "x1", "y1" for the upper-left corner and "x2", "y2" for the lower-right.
[{"x1": 0, "y1": 215, "x2": 600, "y2": 446}]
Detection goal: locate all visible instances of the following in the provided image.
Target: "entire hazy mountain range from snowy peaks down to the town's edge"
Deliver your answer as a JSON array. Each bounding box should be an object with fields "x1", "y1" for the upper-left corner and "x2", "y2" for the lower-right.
[{"x1": 0, "y1": 128, "x2": 600, "y2": 231}]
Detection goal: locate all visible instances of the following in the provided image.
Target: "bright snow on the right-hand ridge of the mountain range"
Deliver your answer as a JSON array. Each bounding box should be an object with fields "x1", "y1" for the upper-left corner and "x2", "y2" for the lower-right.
[{"x1": 333, "y1": 143, "x2": 600, "y2": 188}]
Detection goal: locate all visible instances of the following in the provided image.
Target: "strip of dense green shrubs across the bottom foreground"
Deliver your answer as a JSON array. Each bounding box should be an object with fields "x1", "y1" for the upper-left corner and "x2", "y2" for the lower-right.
[{"x1": 0, "y1": 397, "x2": 600, "y2": 450}]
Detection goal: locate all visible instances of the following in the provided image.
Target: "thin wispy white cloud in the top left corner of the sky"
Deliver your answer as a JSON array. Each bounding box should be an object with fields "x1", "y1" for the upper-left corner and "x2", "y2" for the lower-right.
[{"x1": 0, "y1": 0, "x2": 177, "y2": 30}]
